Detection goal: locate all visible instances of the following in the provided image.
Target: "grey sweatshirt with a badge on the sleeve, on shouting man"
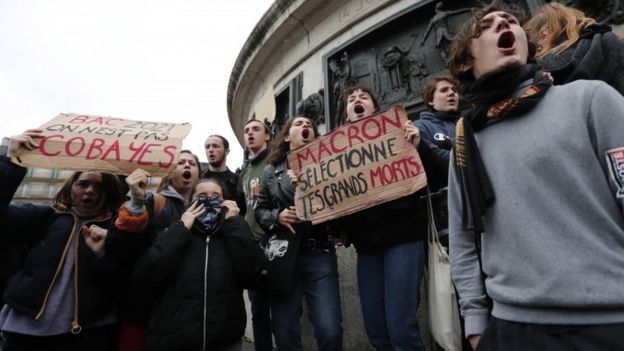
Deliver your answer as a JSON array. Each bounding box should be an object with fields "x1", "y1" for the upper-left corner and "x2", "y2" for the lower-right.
[{"x1": 449, "y1": 80, "x2": 624, "y2": 335}]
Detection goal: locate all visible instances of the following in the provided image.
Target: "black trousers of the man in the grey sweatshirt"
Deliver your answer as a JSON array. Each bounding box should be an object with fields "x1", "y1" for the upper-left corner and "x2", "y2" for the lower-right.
[{"x1": 477, "y1": 316, "x2": 624, "y2": 351}]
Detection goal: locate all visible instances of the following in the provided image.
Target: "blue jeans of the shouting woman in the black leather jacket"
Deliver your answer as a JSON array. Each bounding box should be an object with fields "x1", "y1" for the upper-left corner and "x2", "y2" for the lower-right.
[{"x1": 271, "y1": 249, "x2": 342, "y2": 351}]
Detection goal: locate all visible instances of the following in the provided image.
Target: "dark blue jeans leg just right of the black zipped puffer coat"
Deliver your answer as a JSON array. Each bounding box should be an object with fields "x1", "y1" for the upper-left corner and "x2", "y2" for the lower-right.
[{"x1": 247, "y1": 289, "x2": 273, "y2": 351}]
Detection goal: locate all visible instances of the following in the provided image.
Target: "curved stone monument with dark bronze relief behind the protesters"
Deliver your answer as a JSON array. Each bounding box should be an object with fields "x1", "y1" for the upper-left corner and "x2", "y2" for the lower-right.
[{"x1": 227, "y1": 0, "x2": 624, "y2": 138}]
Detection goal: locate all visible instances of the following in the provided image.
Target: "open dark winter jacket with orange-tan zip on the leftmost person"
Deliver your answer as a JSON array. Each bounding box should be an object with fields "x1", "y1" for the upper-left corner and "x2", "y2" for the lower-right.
[{"x1": 0, "y1": 156, "x2": 120, "y2": 332}]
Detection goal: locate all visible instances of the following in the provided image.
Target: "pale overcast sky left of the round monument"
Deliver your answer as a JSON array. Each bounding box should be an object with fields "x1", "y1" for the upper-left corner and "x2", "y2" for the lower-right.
[{"x1": 0, "y1": 0, "x2": 272, "y2": 169}]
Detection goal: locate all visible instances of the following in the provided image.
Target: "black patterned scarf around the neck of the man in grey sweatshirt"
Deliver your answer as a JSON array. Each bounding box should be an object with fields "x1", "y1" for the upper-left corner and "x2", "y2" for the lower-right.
[{"x1": 454, "y1": 64, "x2": 552, "y2": 233}]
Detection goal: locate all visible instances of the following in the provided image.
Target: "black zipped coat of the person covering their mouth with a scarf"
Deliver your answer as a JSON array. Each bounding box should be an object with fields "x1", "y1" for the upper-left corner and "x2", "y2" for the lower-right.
[{"x1": 133, "y1": 216, "x2": 259, "y2": 351}]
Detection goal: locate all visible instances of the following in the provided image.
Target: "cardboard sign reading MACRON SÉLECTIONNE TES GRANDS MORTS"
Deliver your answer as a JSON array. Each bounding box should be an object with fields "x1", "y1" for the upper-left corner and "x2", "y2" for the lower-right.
[{"x1": 288, "y1": 106, "x2": 427, "y2": 224}]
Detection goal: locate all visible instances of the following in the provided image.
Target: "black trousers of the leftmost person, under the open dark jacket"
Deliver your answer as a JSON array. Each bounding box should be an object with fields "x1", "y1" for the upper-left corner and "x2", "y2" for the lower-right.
[{"x1": 2, "y1": 325, "x2": 117, "y2": 351}]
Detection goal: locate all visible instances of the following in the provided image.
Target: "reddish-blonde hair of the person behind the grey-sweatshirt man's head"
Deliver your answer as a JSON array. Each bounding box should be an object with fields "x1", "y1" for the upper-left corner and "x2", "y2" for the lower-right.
[{"x1": 524, "y1": 2, "x2": 596, "y2": 59}]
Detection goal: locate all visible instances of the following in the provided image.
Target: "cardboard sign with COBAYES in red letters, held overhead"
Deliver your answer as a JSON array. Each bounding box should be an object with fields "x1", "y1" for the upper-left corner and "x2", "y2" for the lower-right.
[{"x1": 12, "y1": 113, "x2": 191, "y2": 176}]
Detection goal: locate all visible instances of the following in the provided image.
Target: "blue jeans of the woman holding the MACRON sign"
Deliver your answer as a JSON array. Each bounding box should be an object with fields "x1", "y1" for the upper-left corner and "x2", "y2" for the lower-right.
[{"x1": 357, "y1": 240, "x2": 425, "y2": 351}]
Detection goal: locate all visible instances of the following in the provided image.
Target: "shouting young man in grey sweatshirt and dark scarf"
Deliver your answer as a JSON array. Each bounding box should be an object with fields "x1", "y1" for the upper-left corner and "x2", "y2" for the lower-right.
[{"x1": 449, "y1": 4, "x2": 624, "y2": 351}]
